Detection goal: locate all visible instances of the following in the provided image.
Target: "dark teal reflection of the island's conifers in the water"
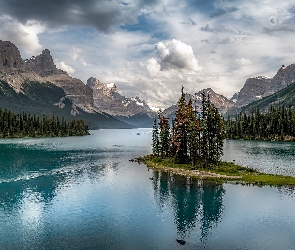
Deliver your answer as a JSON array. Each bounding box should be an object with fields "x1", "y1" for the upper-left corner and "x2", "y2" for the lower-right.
[{"x1": 152, "y1": 171, "x2": 225, "y2": 241}]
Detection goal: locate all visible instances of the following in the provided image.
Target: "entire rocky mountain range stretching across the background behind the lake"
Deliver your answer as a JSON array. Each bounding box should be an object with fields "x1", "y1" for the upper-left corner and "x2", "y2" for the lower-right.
[{"x1": 0, "y1": 40, "x2": 295, "y2": 129}]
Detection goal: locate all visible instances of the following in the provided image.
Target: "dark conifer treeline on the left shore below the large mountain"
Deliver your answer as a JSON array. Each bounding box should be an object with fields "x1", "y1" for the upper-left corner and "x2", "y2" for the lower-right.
[{"x1": 0, "y1": 109, "x2": 89, "y2": 138}]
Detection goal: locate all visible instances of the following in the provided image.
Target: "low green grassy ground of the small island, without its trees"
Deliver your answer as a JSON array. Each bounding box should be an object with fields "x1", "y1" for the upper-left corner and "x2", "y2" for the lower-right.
[{"x1": 137, "y1": 155, "x2": 295, "y2": 186}]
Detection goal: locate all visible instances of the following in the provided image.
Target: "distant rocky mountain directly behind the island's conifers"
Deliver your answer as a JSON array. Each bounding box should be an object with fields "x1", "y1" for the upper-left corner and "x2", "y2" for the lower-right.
[{"x1": 163, "y1": 88, "x2": 234, "y2": 118}]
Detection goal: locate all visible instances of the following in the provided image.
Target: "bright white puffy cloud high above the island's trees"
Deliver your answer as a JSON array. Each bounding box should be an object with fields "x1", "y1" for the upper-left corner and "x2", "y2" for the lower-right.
[{"x1": 155, "y1": 39, "x2": 201, "y2": 71}]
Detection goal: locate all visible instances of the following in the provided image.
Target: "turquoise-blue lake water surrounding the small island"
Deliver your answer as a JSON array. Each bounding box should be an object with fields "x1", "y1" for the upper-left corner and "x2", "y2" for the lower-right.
[{"x1": 0, "y1": 129, "x2": 295, "y2": 249}]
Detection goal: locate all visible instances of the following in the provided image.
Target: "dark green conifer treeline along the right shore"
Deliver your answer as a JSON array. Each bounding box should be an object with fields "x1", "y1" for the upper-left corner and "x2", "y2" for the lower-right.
[{"x1": 226, "y1": 106, "x2": 295, "y2": 141}]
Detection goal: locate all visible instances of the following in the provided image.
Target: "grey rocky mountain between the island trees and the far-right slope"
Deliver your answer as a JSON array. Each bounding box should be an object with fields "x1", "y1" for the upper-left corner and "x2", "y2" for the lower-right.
[{"x1": 235, "y1": 76, "x2": 272, "y2": 108}]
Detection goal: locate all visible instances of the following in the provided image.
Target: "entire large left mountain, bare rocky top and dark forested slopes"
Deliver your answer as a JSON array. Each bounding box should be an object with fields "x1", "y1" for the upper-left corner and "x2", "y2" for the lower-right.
[{"x1": 0, "y1": 40, "x2": 133, "y2": 129}]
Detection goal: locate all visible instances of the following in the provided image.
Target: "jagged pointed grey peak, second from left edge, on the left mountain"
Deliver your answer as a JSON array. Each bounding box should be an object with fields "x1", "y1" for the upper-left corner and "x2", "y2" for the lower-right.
[{"x1": 25, "y1": 49, "x2": 67, "y2": 77}]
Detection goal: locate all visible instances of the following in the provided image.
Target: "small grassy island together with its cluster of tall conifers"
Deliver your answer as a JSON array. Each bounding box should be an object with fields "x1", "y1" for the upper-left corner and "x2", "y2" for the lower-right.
[{"x1": 136, "y1": 87, "x2": 295, "y2": 186}]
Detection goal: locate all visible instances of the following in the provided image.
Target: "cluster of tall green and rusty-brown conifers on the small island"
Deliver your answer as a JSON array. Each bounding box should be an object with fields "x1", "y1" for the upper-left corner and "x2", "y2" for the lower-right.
[{"x1": 152, "y1": 88, "x2": 225, "y2": 167}]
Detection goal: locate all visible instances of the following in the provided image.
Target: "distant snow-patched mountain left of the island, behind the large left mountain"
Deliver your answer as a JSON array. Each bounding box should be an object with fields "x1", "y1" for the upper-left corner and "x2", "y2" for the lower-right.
[{"x1": 87, "y1": 77, "x2": 152, "y2": 117}]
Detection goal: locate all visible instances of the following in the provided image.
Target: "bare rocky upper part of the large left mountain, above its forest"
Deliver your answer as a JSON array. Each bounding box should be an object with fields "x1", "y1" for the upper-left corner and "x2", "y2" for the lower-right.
[{"x1": 0, "y1": 40, "x2": 95, "y2": 112}]
